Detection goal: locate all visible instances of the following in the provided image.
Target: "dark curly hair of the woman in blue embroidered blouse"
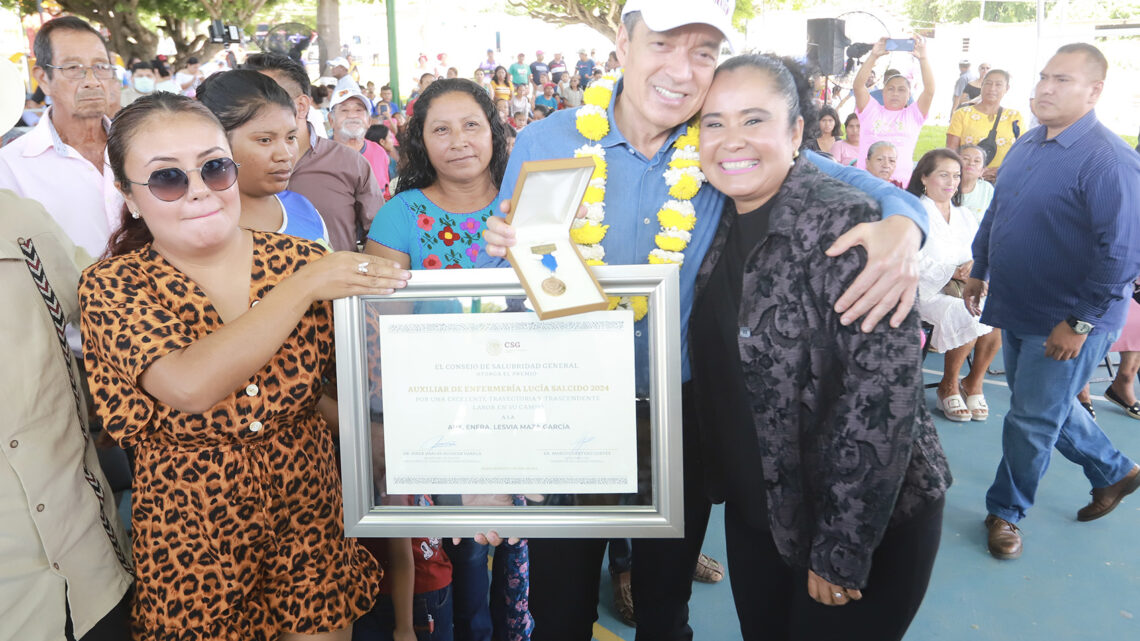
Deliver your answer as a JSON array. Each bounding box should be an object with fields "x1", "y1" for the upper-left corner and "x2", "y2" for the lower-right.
[{"x1": 396, "y1": 78, "x2": 511, "y2": 194}]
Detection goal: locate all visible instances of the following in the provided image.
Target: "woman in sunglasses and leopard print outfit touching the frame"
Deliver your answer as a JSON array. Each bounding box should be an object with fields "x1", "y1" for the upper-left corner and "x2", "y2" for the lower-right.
[{"x1": 79, "y1": 94, "x2": 410, "y2": 641}]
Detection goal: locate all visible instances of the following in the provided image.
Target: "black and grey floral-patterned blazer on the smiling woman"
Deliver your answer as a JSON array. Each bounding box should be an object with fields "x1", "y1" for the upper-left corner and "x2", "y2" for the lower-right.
[{"x1": 694, "y1": 159, "x2": 951, "y2": 589}]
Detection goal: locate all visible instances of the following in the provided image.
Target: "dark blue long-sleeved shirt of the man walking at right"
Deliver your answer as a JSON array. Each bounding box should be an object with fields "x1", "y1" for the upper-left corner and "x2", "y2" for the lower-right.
[{"x1": 971, "y1": 111, "x2": 1140, "y2": 335}]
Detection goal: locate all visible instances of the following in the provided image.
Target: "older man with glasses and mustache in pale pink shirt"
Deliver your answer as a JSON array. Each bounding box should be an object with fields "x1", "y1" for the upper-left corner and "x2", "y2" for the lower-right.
[{"x1": 0, "y1": 16, "x2": 123, "y2": 257}]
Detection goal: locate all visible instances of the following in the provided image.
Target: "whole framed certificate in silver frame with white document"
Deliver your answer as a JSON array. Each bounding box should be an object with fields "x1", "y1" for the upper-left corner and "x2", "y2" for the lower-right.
[{"x1": 334, "y1": 266, "x2": 683, "y2": 537}]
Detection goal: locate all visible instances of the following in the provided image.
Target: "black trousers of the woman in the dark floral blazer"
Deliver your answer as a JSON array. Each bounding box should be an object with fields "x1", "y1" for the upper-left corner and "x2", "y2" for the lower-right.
[{"x1": 724, "y1": 498, "x2": 945, "y2": 641}]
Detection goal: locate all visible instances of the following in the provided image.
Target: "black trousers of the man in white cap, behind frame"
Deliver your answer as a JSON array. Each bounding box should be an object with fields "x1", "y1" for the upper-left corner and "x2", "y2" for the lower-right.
[{"x1": 530, "y1": 386, "x2": 710, "y2": 641}]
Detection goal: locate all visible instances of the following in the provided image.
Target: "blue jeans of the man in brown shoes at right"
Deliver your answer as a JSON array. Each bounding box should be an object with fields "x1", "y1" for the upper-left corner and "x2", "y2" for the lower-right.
[{"x1": 986, "y1": 331, "x2": 1134, "y2": 524}]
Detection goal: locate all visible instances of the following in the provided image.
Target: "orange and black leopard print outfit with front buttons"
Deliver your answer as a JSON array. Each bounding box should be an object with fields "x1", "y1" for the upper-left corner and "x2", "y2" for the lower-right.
[{"x1": 79, "y1": 232, "x2": 380, "y2": 641}]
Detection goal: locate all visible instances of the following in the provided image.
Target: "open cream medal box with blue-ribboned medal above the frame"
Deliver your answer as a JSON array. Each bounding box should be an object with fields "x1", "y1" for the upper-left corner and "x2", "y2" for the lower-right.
[{"x1": 506, "y1": 157, "x2": 608, "y2": 321}]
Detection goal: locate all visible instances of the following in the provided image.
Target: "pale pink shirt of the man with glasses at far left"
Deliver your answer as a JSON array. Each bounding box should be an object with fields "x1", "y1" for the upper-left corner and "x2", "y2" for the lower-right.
[{"x1": 0, "y1": 107, "x2": 121, "y2": 258}]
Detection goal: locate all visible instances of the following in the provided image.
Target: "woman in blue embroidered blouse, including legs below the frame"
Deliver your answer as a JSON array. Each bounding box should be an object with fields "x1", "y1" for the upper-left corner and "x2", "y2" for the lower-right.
[{"x1": 365, "y1": 79, "x2": 534, "y2": 641}]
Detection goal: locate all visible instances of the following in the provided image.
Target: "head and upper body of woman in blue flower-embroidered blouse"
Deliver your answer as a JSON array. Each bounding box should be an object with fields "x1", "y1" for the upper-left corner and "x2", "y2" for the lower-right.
[{"x1": 365, "y1": 79, "x2": 510, "y2": 269}]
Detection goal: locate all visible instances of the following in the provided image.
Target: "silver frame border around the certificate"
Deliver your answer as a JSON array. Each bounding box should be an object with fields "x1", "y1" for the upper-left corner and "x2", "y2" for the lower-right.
[{"x1": 333, "y1": 265, "x2": 684, "y2": 538}]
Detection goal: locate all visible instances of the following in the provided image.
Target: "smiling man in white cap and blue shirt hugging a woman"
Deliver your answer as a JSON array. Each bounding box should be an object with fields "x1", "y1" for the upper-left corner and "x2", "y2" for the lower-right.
[{"x1": 479, "y1": 0, "x2": 926, "y2": 641}]
